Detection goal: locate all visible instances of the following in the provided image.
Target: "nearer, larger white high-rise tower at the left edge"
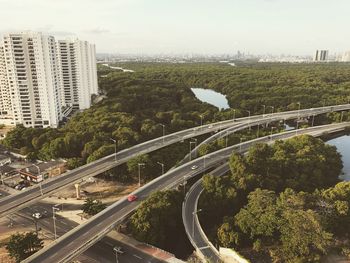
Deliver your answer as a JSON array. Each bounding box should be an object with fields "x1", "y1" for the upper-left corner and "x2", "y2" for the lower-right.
[{"x1": 0, "y1": 32, "x2": 61, "y2": 127}]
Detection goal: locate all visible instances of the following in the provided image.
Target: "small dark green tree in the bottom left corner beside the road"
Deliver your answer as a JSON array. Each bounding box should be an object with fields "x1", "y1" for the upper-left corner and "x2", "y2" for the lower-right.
[{"x1": 5, "y1": 232, "x2": 44, "y2": 262}]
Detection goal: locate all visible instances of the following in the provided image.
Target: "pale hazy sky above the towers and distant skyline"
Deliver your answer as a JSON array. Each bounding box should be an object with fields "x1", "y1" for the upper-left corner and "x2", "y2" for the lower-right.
[{"x1": 0, "y1": 0, "x2": 350, "y2": 56}]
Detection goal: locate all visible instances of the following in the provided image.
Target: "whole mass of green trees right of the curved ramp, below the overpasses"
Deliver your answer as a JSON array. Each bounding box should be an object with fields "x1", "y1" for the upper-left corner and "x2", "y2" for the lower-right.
[{"x1": 199, "y1": 135, "x2": 350, "y2": 262}]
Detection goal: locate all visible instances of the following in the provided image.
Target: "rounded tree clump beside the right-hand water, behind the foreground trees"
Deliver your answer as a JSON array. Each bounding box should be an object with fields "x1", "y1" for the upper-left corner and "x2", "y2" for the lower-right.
[{"x1": 230, "y1": 135, "x2": 343, "y2": 192}]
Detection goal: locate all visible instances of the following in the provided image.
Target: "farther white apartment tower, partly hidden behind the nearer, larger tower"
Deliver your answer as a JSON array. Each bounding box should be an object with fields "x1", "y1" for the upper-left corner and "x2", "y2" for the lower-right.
[{"x1": 57, "y1": 39, "x2": 98, "y2": 109}]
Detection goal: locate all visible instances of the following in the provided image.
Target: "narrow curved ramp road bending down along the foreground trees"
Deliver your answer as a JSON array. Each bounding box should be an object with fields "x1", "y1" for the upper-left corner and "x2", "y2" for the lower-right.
[{"x1": 182, "y1": 163, "x2": 230, "y2": 263}]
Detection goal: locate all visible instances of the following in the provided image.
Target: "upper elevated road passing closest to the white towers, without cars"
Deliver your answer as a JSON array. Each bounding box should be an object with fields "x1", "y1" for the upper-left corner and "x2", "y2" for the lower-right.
[{"x1": 0, "y1": 104, "x2": 350, "y2": 219}]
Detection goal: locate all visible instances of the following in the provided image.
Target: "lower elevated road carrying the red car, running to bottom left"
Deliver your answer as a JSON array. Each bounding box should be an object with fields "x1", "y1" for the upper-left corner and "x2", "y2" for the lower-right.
[{"x1": 24, "y1": 123, "x2": 350, "y2": 263}]
